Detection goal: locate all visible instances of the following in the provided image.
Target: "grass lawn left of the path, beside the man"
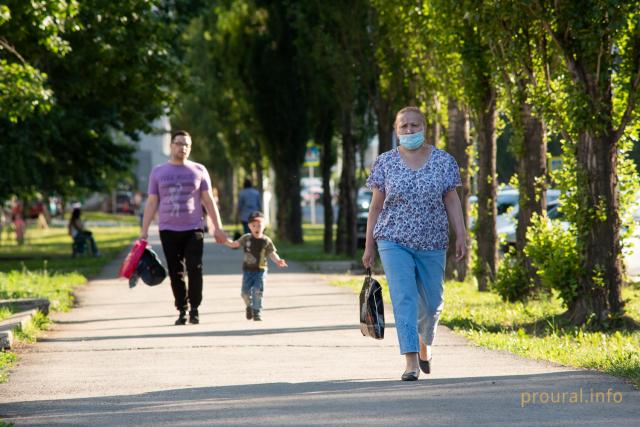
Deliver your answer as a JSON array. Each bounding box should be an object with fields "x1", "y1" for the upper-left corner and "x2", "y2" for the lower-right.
[{"x1": 0, "y1": 213, "x2": 139, "y2": 382}]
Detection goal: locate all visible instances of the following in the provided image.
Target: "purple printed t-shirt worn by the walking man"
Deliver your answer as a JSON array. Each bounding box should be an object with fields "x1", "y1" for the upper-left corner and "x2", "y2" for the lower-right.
[{"x1": 149, "y1": 160, "x2": 211, "y2": 231}]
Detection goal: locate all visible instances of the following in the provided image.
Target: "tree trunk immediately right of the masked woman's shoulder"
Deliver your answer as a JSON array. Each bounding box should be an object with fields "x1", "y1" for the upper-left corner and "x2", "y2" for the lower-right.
[{"x1": 445, "y1": 98, "x2": 471, "y2": 282}]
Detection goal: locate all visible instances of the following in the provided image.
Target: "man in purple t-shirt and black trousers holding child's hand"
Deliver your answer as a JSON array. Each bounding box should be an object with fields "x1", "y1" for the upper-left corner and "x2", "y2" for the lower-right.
[{"x1": 140, "y1": 131, "x2": 227, "y2": 325}]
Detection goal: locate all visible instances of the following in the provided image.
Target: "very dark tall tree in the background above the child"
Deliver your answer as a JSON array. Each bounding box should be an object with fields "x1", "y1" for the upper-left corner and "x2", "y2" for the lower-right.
[{"x1": 246, "y1": 0, "x2": 309, "y2": 243}]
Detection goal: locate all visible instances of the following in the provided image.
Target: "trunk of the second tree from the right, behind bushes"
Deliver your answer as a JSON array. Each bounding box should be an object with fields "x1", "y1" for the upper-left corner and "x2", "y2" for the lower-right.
[{"x1": 516, "y1": 102, "x2": 547, "y2": 294}]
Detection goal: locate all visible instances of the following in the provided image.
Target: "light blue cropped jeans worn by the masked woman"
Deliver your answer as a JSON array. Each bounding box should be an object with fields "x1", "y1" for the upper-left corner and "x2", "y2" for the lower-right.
[{"x1": 377, "y1": 240, "x2": 446, "y2": 354}]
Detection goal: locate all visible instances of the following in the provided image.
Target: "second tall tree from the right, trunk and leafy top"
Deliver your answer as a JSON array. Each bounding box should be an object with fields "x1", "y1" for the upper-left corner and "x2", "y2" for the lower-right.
[{"x1": 488, "y1": 0, "x2": 547, "y2": 298}]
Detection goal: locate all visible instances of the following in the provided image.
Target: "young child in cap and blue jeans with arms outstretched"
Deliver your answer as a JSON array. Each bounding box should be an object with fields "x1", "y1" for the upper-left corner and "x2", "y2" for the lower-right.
[{"x1": 225, "y1": 211, "x2": 287, "y2": 321}]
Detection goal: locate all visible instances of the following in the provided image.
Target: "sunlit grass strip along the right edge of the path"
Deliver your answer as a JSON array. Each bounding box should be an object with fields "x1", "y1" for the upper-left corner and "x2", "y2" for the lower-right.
[{"x1": 333, "y1": 278, "x2": 640, "y2": 386}]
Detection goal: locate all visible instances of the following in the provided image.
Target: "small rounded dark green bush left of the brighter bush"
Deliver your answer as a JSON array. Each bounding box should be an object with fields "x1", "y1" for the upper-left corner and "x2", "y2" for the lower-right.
[{"x1": 493, "y1": 250, "x2": 535, "y2": 302}]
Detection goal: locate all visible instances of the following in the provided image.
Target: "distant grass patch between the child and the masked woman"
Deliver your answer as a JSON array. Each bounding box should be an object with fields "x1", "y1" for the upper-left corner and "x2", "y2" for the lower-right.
[{"x1": 274, "y1": 224, "x2": 363, "y2": 262}]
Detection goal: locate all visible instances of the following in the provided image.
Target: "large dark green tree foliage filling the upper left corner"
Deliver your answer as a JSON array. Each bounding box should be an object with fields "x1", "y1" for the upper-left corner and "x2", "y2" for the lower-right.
[{"x1": 0, "y1": 0, "x2": 196, "y2": 199}]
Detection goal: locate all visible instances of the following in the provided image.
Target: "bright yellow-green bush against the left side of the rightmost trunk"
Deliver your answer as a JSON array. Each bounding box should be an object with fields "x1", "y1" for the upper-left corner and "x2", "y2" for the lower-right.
[{"x1": 524, "y1": 215, "x2": 583, "y2": 307}]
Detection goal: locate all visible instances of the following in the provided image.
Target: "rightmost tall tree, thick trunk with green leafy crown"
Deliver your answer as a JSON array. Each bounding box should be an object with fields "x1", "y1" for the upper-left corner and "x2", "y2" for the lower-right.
[{"x1": 522, "y1": 0, "x2": 640, "y2": 323}]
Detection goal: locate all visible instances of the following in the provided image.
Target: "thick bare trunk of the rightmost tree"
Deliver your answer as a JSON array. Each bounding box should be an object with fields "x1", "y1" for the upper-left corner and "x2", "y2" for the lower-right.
[{"x1": 567, "y1": 130, "x2": 623, "y2": 324}]
